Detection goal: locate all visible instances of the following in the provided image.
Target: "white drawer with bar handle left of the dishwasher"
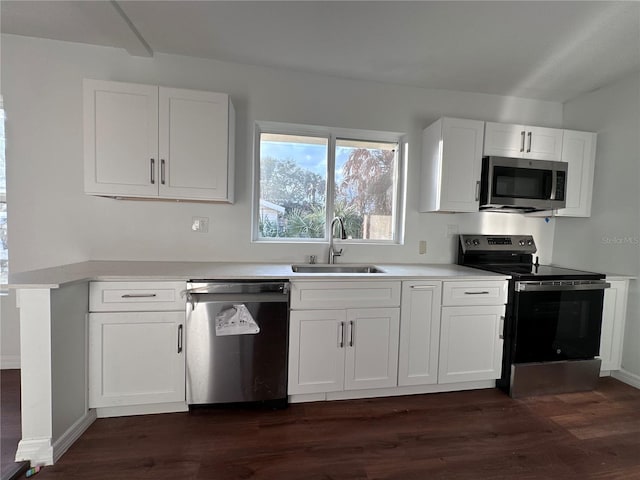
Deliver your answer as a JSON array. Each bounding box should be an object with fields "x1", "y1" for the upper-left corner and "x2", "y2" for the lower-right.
[{"x1": 89, "y1": 282, "x2": 186, "y2": 312}]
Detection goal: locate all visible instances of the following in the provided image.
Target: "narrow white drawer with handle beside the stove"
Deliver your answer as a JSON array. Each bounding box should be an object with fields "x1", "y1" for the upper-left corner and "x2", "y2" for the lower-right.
[{"x1": 442, "y1": 280, "x2": 507, "y2": 306}]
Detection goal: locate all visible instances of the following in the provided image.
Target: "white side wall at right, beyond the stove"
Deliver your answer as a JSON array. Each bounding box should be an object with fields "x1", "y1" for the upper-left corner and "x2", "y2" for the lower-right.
[{"x1": 553, "y1": 73, "x2": 640, "y2": 380}]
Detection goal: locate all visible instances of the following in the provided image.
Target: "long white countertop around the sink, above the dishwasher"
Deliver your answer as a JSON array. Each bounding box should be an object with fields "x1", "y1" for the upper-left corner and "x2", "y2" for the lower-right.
[{"x1": 9, "y1": 261, "x2": 509, "y2": 288}]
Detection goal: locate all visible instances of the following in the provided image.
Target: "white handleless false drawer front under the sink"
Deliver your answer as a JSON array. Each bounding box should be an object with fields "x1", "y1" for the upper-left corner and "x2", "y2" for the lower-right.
[{"x1": 291, "y1": 280, "x2": 400, "y2": 310}]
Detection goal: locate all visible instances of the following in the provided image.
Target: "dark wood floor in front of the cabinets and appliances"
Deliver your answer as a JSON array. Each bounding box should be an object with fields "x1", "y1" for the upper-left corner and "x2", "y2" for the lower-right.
[{"x1": 10, "y1": 378, "x2": 640, "y2": 480}]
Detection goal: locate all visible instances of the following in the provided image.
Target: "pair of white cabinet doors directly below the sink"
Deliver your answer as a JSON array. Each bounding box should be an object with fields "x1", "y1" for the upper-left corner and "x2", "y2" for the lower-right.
[{"x1": 288, "y1": 308, "x2": 400, "y2": 394}]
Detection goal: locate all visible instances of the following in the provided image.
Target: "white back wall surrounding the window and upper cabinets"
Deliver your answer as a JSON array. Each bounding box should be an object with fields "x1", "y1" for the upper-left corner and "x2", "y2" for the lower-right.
[{"x1": 2, "y1": 35, "x2": 562, "y2": 278}]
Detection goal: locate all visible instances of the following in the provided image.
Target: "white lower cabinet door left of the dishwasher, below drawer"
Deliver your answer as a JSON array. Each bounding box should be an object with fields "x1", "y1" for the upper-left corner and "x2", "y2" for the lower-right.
[{"x1": 89, "y1": 312, "x2": 185, "y2": 408}]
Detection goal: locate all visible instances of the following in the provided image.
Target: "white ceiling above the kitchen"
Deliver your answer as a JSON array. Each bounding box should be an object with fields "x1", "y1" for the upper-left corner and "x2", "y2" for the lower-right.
[{"x1": 0, "y1": 0, "x2": 640, "y2": 102}]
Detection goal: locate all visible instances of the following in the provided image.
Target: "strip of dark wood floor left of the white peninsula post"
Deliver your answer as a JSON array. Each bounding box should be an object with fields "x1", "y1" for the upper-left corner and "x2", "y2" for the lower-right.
[{"x1": 0, "y1": 370, "x2": 23, "y2": 480}]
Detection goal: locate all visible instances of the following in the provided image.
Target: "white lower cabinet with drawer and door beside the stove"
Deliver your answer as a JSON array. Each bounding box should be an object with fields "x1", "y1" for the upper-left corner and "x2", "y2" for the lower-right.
[{"x1": 438, "y1": 281, "x2": 507, "y2": 383}]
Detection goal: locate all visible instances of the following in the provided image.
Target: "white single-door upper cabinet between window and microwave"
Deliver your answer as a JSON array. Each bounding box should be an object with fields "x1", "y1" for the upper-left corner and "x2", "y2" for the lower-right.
[{"x1": 419, "y1": 118, "x2": 484, "y2": 212}]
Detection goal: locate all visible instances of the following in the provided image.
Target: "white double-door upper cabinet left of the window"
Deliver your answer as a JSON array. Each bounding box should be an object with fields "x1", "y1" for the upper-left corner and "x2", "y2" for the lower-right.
[{"x1": 84, "y1": 80, "x2": 235, "y2": 202}]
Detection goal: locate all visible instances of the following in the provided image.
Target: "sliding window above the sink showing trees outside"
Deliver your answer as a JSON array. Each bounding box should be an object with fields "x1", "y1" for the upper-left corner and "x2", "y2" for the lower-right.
[{"x1": 254, "y1": 124, "x2": 404, "y2": 243}]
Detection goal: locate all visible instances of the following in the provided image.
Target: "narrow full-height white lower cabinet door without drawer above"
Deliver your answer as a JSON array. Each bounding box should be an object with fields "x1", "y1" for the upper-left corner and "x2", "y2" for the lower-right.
[{"x1": 398, "y1": 282, "x2": 442, "y2": 385}]
